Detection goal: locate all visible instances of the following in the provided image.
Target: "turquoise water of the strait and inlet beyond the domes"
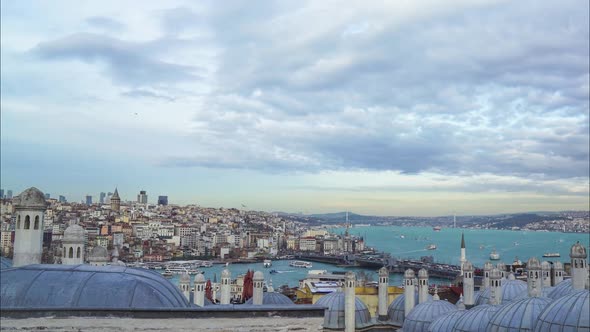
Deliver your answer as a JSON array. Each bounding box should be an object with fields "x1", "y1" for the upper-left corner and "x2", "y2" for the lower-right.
[{"x1": 164, "y1": 226, "x2": 588, "y2": 288}]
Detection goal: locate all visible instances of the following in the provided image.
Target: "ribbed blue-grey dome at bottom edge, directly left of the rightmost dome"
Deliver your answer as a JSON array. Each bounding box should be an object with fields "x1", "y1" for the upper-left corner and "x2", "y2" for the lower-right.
[{"x1": 486, "y1": 297, "x2": 551, "y2": 332}]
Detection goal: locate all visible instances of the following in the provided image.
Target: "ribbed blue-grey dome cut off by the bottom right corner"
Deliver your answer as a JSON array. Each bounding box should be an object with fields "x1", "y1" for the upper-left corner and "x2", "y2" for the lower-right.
[{"x1": 535, "y1": 290, "x2": 590, "y2": 332}]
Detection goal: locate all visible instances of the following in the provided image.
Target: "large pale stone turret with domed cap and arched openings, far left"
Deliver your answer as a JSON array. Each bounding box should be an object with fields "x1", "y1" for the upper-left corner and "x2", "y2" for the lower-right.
[{"x1": 12, "y1": 187, "x2": 47, "y2": 267}]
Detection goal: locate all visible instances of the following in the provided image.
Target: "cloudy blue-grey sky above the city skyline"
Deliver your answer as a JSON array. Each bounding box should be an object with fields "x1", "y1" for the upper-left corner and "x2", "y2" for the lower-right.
[{"x1": 0, "y1": 0, "x2": 590, "y2": 216}]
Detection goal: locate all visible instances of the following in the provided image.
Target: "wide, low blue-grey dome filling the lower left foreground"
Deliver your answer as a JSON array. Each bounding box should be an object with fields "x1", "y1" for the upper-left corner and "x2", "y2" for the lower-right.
[{"x1": 0, "y1": 265, "x2": 190, "y2": 310}]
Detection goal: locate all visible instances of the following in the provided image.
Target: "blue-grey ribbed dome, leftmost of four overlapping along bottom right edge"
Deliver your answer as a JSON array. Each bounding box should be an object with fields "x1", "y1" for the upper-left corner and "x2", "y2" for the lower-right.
[{"x1": 402, "y1": 300, "x2": 457, "y2": 332}]
